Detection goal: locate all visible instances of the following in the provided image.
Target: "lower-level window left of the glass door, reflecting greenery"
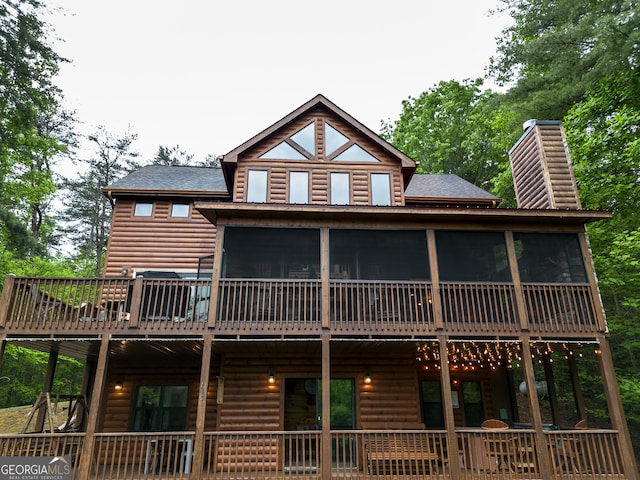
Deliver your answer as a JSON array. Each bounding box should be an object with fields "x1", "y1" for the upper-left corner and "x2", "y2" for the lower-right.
[{"x1": 131, "y1": 385, "x2": 189, "y2": 432}]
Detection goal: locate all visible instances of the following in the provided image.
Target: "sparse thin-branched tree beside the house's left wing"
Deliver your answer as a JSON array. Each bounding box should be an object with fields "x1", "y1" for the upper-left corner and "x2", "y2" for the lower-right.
[{"x1": 61, "y1": 126, "x2": 140, "y2": 277}]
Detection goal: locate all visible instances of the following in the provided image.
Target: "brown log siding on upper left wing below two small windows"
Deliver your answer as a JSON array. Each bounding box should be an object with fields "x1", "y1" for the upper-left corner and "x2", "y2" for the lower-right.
[{"x1": 104, "y1": 200, "x2": 216, "y2": 276}]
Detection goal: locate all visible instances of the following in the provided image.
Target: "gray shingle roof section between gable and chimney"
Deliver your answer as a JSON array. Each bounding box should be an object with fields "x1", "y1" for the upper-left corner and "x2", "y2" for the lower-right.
[{"x1": 405, "y1": 174, "x2": 498, "y2": 200}]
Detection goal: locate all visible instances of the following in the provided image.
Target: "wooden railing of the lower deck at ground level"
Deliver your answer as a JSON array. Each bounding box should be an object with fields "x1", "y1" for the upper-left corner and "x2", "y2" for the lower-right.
[{"x1": 0, "y1": 429, "x2": 628, "y2": 480}]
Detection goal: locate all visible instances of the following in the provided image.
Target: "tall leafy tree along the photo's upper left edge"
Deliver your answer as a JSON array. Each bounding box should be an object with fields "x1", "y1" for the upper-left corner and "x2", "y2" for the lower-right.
[{"x1": 0, "y1": 0, "x2": 71, "y2": 256}]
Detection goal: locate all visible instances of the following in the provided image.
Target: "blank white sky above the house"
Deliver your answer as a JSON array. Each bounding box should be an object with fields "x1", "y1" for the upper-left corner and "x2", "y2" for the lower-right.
[{"x1": 48, "y1": 0, "x2": 509, "y2": 169}]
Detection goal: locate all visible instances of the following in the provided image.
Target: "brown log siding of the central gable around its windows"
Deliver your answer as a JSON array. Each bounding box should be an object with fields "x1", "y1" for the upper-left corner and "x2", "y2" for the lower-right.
[{"x1": 233, "y1": 111, "x2": 404, "y2": 205}]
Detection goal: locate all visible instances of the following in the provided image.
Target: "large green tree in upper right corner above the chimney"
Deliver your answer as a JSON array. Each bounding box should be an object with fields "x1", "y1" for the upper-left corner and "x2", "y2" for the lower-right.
[{"x1": 489, "y1": 0, "x2": 640, "y2": 123}]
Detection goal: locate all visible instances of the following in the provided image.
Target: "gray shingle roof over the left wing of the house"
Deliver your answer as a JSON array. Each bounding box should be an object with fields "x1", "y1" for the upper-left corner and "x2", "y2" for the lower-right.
[{"x1": 105, "y1": 165, "x2": 227, "y2": 193}]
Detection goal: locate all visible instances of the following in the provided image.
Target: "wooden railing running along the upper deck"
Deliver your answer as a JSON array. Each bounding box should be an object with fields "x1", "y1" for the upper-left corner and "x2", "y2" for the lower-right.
[{"x1": 0, "y1": 276, "x2": 604, "y2": 336}]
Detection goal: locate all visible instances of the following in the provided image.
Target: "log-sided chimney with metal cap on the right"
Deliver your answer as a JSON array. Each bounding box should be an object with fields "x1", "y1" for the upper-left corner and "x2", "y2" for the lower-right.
[{"x1": 509, "y1": 120, "x2": 580, "y2": 210}]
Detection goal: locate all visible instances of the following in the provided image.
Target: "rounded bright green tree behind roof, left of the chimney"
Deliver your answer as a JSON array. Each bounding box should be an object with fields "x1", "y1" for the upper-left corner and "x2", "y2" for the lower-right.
[{"x1": 382, "y1": 79, "x2": 512, "y2": 194}]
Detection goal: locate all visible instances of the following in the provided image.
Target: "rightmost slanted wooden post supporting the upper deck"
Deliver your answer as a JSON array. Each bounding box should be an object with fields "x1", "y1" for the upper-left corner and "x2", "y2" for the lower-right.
[{"x1": 598, "y1": 336, "x2": 639, "y2": 480}]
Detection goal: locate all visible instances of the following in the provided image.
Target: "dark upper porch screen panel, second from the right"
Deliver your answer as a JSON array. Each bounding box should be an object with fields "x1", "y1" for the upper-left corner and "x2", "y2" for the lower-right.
[{"x1": 436, "y1": 231, "x2": 511, "y2": 282}]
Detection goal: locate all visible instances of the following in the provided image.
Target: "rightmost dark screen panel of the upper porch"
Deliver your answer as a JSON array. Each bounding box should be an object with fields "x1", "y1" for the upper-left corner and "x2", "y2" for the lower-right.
[{"x1": 513, "y1": 233, "x2": 587, "y2": 283}]
